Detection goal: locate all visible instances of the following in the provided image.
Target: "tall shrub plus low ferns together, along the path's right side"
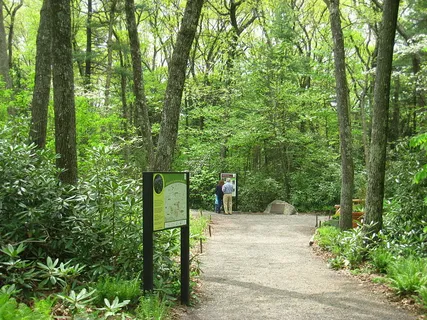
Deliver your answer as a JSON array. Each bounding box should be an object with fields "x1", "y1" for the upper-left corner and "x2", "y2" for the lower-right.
[{"x1": 315, "y1": 138, "x2": 427, "y2": 307}]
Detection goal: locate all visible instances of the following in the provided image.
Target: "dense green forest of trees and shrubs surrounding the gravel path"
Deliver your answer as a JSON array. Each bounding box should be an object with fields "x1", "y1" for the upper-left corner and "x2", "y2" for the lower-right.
[{"x1": 0, "y1": 0, "x2": 427, "y2": 319}]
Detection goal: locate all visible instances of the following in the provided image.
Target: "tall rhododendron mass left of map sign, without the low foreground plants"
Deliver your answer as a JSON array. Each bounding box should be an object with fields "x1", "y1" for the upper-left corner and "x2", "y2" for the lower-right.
[{"x1": 0, "y1": 129, "x2": 142, "y2": 282}]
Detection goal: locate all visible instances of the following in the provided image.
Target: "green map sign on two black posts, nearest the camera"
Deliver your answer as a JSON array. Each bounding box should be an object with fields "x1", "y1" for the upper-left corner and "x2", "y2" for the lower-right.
[{"x1": 143, "y1": 172, "x2": 190, "y2": 305}]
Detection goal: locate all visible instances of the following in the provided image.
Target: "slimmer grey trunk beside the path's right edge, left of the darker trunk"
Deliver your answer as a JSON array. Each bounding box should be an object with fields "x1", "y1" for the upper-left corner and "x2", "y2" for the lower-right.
[{"x1": 325, "y1": 0, "x2": 354, "y2": 230}]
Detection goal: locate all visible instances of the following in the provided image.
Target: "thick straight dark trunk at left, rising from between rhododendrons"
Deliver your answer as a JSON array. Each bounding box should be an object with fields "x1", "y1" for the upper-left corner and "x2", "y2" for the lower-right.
[{"x1": 51, "y1": 0, "x2": 77, "y2": 184}]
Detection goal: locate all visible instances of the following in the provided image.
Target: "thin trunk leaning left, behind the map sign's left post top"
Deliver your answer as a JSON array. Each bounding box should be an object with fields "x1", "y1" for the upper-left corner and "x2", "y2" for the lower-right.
[{"x1": 125, "y1": 0, "x2": 154, "y2": 169}]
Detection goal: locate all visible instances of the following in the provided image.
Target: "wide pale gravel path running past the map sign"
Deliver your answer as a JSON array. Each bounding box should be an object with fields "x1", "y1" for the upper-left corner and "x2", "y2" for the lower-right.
[{"x1": 175, "y1": 212, "x2": 424, "y2": 320}]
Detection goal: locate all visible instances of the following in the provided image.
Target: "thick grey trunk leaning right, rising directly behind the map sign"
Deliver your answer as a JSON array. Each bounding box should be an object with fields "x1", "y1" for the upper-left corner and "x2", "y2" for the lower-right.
[{"x1": 154, "y1": 0, "x2": 204, "y2": 171}]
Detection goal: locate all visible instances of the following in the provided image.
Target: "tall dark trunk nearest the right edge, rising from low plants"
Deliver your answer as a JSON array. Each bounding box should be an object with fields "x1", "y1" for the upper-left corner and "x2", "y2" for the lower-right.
[{"x1": 364, "y1": 0, "x2": 399, "y2": 233}]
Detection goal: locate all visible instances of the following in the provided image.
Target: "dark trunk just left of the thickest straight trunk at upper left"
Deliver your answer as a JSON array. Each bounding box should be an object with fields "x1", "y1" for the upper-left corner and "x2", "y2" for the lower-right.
[{"x1": 30, "y1": 0, "x2": 52, "y2": 148}]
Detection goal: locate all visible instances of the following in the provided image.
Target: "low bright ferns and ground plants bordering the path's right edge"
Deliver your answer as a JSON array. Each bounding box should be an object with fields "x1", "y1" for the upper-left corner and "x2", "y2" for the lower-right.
[{"x1": 315, "y1": 222, "x2": 427, "y2": 306}]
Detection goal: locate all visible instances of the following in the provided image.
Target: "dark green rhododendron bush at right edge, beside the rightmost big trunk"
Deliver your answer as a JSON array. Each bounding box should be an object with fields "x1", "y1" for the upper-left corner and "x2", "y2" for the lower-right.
[{"x1": 383, "y1": 137, "x2": 427, "y2": 257}]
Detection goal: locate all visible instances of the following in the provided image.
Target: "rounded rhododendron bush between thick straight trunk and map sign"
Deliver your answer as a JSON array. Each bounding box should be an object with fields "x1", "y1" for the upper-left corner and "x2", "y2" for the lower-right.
[{"x1": 59, "y1": 146, "x2": 142, "y2": 279}]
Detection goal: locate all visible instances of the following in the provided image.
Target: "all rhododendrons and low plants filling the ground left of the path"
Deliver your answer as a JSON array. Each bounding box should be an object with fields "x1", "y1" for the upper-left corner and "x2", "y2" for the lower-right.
[{"x1": 0, "y1": 121, "x2": 208, "y2": 320}]
